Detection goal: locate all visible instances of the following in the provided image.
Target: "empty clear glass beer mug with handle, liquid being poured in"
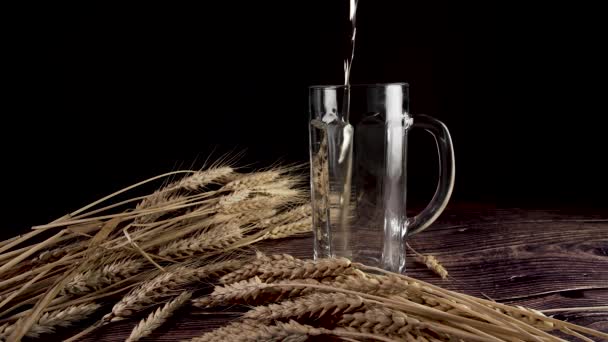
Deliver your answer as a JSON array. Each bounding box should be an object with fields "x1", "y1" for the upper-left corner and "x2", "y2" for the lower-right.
[{"x1": 309, "y1": 83, "x2": 455, "y2": 272}]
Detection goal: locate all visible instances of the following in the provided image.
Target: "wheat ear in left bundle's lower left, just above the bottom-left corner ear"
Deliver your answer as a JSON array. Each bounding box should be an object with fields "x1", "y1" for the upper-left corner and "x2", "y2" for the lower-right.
[{"x1": 61, "y1": 259, "x2": 144, "y2": 296}]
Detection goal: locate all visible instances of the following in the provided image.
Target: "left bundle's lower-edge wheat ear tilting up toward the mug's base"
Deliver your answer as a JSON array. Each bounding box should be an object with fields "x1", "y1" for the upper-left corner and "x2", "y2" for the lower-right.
[{"x1": 158, "y1": 223, "x2": 243, "y2": 257}]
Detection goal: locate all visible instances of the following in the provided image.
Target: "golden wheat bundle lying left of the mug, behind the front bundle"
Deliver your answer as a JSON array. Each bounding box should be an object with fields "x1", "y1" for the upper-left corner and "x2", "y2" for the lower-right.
[{"x1": 0, "y1": 164, "x2": 311, "y2": 341}]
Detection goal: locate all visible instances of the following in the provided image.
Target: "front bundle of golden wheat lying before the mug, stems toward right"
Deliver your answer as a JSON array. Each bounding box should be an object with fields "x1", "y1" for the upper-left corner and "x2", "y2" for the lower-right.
[{"x1": 192, "y1": 255, "x2": 608, "y2": 342}]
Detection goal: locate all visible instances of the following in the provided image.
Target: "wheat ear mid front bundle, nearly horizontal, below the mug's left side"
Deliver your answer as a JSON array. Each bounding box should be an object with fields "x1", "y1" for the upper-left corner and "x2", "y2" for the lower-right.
[{"x1": 243, "y1": 292, "x2": 364, "y2": 323}]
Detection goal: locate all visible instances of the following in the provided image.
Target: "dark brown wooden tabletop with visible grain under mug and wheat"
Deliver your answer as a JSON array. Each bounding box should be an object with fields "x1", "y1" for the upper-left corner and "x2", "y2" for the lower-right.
[{"x1": 78, "y1": 205, "x2": 608, "y2": 342}]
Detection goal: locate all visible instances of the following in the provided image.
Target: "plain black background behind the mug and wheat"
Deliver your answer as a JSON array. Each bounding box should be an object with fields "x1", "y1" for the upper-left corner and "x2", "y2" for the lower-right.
[{"x1": 2, "y1": 0, "x2": 608, "y2": 235}]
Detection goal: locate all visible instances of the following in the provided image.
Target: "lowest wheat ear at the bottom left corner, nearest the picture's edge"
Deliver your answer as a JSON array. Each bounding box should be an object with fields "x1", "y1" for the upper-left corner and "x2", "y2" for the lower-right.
[{"x1": 0, "y1": 303, "x2": 101, "y2": 341}]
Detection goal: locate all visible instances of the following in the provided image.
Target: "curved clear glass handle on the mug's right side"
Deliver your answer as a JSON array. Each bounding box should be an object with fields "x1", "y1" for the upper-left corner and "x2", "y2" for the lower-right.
[{"x1": 405, "y1": 114, "x2": 456, "y2": 238}]
